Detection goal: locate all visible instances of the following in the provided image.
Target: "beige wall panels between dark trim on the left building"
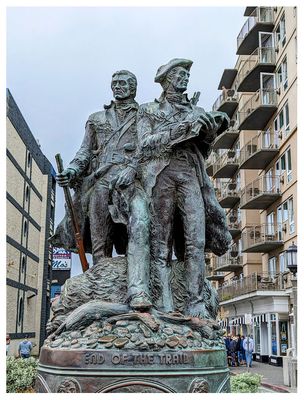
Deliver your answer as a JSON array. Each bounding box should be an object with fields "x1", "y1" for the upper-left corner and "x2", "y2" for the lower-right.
[{"x1": 6, "y1": 115, "x2": 48, "y2": 355}]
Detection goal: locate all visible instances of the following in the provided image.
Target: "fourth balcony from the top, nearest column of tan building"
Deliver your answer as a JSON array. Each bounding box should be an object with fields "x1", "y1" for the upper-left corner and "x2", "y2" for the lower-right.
[{"x1": 240, "y1": 132, "x2": 279, "y2": 169}]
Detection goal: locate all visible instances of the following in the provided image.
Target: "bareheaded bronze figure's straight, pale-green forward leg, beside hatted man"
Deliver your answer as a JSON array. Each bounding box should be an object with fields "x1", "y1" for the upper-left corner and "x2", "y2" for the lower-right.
[{"x1": 128, "y1": 188, "x2": 152, "y2": 310}]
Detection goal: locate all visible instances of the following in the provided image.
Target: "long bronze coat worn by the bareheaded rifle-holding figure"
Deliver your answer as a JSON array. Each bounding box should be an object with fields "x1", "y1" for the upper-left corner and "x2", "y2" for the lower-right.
[{"x1": 50, "y1": 101, "x2": 138, "y2": 254}]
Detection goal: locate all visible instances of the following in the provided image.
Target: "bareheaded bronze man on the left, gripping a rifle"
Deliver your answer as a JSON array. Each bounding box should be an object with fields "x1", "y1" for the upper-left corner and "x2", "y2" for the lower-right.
[{"x1": 51, "y1": 70, "x2": 152, "y2": 309}]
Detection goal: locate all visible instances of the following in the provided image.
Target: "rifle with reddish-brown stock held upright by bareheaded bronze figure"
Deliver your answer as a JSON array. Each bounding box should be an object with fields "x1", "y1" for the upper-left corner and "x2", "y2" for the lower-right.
[{"x1": 55, "y1": 153, "x2": 89, "y2": 272}]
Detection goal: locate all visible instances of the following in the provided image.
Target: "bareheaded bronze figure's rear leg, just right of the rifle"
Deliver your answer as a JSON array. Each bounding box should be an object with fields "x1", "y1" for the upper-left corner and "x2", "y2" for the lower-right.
[{"x1": 89, "y1": 182, "x2": 113, "y2": 264}]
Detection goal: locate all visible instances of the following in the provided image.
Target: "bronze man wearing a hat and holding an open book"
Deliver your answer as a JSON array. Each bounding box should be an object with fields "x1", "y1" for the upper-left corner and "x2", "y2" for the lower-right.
[{"x1": 137, "y1": 59, "x2": 231, "y2": 317}]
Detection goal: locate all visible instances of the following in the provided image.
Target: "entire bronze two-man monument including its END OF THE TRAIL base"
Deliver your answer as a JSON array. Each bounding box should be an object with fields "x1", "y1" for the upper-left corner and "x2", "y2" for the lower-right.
[{"x1": 37, "y1": 58, "x2": 231, "y2": 393}]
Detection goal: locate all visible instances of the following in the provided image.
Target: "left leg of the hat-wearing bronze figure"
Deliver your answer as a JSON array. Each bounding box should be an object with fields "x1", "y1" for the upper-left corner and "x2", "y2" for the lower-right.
[{"x1": 150, "y1": 169, "x2": 175, "y2": 312}]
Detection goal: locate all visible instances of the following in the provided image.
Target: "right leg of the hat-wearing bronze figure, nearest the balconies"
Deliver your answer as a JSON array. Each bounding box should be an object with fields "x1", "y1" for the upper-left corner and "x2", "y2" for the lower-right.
[{"x1": 177, "y1": 169, "x2": 205, "y2": 316}]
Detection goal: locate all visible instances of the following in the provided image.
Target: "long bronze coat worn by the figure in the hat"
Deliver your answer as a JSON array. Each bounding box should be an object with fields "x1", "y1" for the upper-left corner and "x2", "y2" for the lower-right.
[{"x1": 137, "y1": 98, "x2": 232, "y2": 258}]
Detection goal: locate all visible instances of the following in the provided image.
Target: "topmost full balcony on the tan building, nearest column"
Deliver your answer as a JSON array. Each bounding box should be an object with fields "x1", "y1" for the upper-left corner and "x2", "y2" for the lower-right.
[{"x1": 236, "y1": 7, "x2": 274, "y2": 55}]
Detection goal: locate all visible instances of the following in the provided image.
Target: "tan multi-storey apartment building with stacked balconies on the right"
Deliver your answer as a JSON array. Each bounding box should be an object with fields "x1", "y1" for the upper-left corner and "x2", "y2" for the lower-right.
[{"x1": 206, "y1": 7, "x2": 297, "y2": 366}]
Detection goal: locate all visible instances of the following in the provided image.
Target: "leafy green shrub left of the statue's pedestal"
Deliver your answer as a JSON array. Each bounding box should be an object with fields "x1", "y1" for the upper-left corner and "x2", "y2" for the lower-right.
[{"x1": 6, "y1": 357, "x2": 38, "y2": 393}]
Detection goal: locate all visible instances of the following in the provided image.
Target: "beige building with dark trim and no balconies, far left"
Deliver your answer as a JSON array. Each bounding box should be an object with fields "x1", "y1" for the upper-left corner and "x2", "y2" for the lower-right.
[{"x1": 6, "y1": 90, "x2": 55, "y2": 355}]
